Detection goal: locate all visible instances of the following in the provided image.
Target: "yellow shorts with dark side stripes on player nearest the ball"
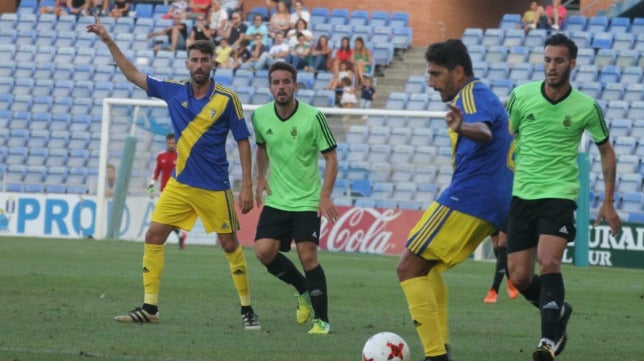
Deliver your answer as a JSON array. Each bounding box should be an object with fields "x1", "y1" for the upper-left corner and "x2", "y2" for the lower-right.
[{"x1": 406, "y1": 202, "x2": 495, "y2": 270}]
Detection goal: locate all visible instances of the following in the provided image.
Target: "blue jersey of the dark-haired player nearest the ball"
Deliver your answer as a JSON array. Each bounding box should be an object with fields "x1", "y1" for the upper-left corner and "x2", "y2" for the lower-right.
[{"x1": 437, "y1": 78, "x2": 513, "y2": 228}]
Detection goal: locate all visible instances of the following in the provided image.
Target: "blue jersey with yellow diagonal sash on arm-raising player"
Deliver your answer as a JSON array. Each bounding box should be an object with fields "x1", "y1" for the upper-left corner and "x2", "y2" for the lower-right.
[{"x1": 147, "y1": 76, "x2": 250, "y2": 190}]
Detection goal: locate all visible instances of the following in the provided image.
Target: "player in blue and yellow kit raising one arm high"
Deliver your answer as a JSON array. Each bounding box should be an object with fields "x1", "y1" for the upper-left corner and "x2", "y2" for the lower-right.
[{"x1": 87, "y1": 16, "x2": 260, "y2": 330}]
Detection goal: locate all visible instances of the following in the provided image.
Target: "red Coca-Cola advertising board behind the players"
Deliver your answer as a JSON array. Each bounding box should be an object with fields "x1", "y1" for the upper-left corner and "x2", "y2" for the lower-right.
[{"x1": 238, "y1": 207, "x2": 423, "y2": 254}]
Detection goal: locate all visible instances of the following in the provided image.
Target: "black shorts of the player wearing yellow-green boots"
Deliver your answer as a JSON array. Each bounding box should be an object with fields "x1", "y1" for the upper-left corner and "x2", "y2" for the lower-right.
[{"x1": 255, "y1": 206, "x2": 320, "y2": 252}]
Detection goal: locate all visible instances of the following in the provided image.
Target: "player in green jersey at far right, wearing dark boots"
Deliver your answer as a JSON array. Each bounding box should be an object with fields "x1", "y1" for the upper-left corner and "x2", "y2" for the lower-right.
[{"x1": 507, "y1": 34, "x2": 621, "y2": 361}]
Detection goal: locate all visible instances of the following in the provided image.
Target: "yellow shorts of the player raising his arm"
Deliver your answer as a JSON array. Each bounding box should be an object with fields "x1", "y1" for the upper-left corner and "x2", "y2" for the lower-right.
[{"x1": 152, "y1": 178, "x2": 239, "y2": 233}]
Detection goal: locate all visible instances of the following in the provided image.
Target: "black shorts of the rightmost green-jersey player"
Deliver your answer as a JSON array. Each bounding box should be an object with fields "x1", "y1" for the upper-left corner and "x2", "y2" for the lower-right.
[{"x1": 507, "y1": 197, "x2": 577, "y2": 253}]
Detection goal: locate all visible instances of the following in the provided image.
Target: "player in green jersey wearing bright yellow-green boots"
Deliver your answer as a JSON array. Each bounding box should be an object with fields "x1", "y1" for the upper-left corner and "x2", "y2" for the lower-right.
[{"x1": 253, "y1": 62, "x2": 338, "y2": 334}]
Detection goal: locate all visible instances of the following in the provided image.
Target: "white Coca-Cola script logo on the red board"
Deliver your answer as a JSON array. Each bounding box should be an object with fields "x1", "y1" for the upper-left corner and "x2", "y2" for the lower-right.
[{"x1": 320, "y1": 208, "x2": 404, "y2": 254}]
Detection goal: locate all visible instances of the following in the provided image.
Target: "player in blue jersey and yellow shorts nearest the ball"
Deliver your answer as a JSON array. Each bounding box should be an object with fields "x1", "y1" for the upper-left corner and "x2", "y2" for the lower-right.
[{"x1": 398, "y1": 40, "x2": 512, "y2": 361}]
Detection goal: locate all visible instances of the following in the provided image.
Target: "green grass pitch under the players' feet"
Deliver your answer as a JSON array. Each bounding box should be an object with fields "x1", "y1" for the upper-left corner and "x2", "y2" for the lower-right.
[{"x1": 0, "y1": 237, "x2": 644, "y2": 361}]
